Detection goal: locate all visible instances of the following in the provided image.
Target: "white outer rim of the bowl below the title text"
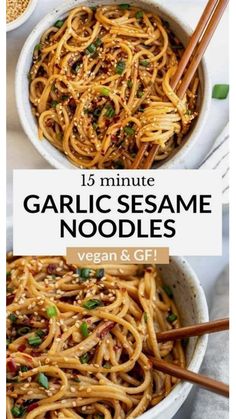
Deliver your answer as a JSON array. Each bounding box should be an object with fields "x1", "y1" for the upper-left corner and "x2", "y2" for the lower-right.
[{"x1": 137, "y1": 256, "x2": 209, "y2": 419}]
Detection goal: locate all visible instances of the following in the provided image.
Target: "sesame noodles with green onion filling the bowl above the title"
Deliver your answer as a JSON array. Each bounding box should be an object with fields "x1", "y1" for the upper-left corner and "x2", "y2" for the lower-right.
[{"x1": 29, "y1": 4, "x2": 199, "y2": 169}]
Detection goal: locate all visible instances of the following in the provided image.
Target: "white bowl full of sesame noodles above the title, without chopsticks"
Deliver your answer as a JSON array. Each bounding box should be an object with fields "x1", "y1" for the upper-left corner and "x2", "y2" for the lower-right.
[{"x1": 16, "y1": 0, "x2": 211, "y2": 169}]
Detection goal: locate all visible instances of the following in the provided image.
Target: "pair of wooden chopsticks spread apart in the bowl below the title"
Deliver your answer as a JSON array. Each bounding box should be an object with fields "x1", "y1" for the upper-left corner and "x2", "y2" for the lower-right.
[{"x1": 154, "y1": 318, "x2": 229, "y2": 397}]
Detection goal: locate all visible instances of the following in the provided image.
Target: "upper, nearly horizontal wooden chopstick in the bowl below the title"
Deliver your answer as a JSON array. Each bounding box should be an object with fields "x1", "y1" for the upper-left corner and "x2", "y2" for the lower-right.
[{"x1": 156, "y1": 318, "x2": 229, "y2": 342}]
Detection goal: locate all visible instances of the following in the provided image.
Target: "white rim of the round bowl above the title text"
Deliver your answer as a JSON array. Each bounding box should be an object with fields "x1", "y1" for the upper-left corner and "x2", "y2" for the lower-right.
[{"x1": 15, "y1": 0, "x2": 211, "y2": 169}]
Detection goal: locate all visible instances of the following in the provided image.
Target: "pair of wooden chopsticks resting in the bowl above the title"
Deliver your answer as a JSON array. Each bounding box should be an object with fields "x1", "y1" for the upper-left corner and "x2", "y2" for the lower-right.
[{"x1": 131, "y1": 0, "x2": 229, "y2": 169}]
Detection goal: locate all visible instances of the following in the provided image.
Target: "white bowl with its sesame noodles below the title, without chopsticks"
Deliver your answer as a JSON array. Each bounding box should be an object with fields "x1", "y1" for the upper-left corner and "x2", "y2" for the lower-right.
[{"x1": 7, "y1": 225, "x2": 208, "y2": 419}]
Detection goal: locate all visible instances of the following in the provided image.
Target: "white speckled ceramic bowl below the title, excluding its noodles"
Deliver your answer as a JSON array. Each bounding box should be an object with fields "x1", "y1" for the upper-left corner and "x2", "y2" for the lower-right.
[{"x1": 7, "y1": 226, "x2": 208, "y2": 419}]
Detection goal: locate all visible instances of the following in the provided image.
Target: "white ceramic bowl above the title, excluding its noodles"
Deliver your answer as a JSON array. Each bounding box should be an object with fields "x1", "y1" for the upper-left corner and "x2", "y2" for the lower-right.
[{"x1": 16, "y1": 0, "x2": 211, "y2": 169}]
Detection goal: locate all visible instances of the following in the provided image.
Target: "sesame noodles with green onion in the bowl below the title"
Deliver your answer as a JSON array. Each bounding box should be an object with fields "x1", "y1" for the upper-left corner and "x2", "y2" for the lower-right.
[{"x1": 7, "y1": 257, "x2": 185, "y2": 419}]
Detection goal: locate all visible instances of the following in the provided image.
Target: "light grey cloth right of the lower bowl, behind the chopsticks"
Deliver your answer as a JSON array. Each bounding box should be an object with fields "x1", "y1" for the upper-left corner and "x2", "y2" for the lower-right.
[{"x1": 191, "y1": 268, "x2": 229, "y2": 419}]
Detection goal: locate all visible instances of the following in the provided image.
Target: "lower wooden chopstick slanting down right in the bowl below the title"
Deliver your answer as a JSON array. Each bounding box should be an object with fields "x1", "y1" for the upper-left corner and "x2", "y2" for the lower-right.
[{"x1": 149, "y1": 357, "x2": 229, "y2": 397}]
